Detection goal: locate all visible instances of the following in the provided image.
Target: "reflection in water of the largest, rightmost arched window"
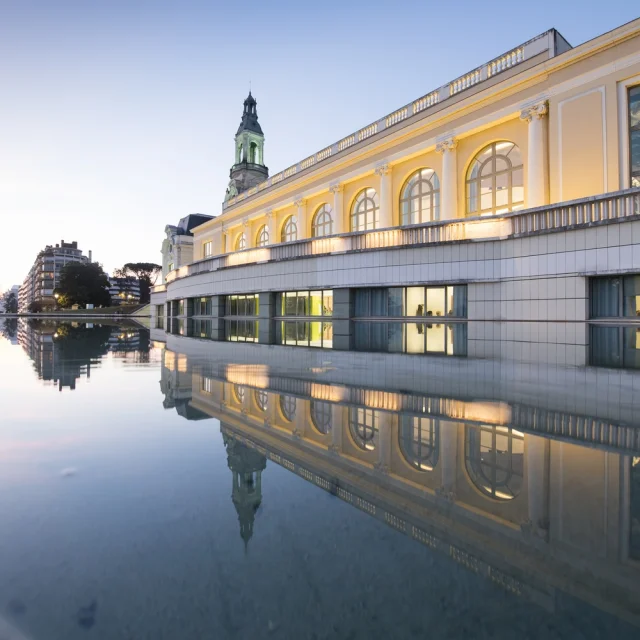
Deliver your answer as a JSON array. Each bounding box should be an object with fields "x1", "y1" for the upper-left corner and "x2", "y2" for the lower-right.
[{"x1": 465, "y1": 425, "x2": 524, "y2": 500}]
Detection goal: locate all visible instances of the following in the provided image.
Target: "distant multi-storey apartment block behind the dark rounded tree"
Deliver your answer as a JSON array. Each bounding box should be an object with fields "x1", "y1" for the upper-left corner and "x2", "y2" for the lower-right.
[{"x1": 18, "y1": 240, "x2": 91, "y2": 313}]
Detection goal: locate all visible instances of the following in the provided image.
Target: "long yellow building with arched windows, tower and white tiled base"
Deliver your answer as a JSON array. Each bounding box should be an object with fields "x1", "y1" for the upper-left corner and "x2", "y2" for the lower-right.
[{"x1": 151, "y1": 19, "x2": 640, "y2": 330}]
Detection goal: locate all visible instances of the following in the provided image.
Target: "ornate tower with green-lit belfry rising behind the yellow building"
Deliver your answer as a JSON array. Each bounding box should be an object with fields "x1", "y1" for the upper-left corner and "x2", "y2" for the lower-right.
[{"x1": 225, "y1": 91, "x2": 269, "y2": 202}]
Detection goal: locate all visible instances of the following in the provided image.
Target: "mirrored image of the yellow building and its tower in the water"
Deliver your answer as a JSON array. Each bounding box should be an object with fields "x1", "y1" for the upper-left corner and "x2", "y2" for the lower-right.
[{"x1": 162, "y1": 340, "x2": 640, "y2": 625}]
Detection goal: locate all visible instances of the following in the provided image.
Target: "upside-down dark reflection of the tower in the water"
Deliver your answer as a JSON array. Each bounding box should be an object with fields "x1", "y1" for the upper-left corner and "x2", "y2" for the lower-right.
[{"x1": 222, "y1": 433, "x2": 267, "y2": 550}]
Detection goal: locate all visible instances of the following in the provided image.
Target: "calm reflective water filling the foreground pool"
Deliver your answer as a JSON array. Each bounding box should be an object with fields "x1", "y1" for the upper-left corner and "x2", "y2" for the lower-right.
[{"x1": 0, "y1": 321, "x2": 640, "y2": 640}]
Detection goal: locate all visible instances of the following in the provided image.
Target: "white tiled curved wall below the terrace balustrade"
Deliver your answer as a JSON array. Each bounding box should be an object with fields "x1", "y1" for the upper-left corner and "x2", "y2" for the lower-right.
[{"x1": 162, "y1": 220, "x2": 640, "y2": 322}]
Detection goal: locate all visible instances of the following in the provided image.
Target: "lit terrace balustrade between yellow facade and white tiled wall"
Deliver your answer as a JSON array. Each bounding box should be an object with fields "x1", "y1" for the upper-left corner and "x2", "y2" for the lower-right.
[{"x1": 152, "y1": 187, "x2": 640, "y2": 293}]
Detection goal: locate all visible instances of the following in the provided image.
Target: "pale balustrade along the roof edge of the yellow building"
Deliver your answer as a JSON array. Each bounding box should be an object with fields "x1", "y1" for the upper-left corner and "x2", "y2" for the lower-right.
[{"x1": 222, "y1": 29, "x2": 571, "y2": 211}]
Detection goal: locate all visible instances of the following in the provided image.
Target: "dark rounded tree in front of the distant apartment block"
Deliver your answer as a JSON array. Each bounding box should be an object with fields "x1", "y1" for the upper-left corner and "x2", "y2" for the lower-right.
[{"x1": 55, "y1": 262, "x2": 111, "y2": 309}]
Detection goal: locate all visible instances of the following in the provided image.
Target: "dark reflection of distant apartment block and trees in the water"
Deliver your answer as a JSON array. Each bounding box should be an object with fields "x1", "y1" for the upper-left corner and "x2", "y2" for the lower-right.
[{"x1": 15, "y1": 319, "x2": 150, "y2": 391}]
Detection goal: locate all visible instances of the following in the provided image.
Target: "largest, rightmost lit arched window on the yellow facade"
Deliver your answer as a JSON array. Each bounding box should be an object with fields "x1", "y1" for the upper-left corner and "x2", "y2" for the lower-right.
[{"x1": 467, "y1": 141, "x2": 524, "y2": 216}]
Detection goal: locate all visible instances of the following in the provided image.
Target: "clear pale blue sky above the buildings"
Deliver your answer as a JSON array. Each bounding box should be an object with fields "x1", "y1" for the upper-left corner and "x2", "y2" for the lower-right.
[{"x1": 0, "y1": 0, "x2": 640, "y2": 291}]
